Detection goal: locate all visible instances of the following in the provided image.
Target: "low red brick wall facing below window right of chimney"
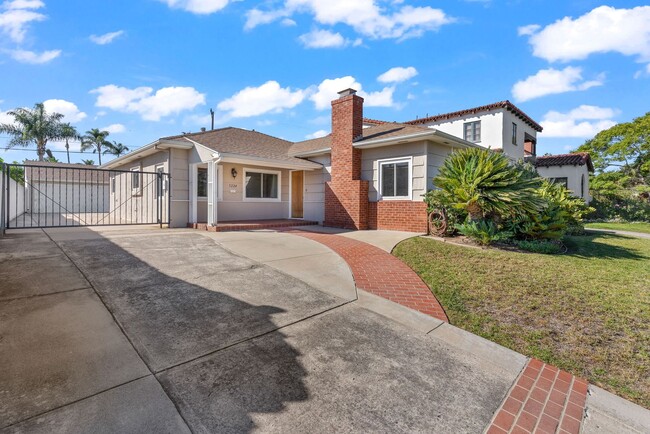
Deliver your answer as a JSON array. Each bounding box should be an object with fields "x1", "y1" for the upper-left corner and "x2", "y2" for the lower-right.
[{"x1": 368, "y1": 200, "x2": 428, "y2": 233}]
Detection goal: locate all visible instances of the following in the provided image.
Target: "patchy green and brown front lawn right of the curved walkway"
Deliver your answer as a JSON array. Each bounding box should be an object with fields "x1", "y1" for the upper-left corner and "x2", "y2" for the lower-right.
[{"x1": 393, "y1": 234, "x2": 650, "y2": 408}]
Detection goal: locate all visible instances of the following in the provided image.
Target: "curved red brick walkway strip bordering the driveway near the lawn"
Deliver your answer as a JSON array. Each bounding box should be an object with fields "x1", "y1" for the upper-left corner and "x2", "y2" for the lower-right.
[{"x1": 288, "y1": 230, "x2": 449, "y2": 322}]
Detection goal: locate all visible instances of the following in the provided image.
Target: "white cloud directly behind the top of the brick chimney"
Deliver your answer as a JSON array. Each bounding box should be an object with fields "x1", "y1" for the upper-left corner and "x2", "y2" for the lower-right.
[{"x1": 309, "y1": 75, "x2": 395, "y2": 110}]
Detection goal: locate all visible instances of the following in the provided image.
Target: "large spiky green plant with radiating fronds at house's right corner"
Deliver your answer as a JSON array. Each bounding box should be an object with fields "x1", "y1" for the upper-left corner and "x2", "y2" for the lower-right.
[{"x1": 433, "y1": 148, "x2": 545, "y2": 221}]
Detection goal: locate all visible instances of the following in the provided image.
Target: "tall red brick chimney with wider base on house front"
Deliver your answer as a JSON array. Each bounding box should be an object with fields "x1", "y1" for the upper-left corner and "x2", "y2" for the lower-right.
[{"x1": 324, "y1": 89, "x2": 368, "y2": 230}]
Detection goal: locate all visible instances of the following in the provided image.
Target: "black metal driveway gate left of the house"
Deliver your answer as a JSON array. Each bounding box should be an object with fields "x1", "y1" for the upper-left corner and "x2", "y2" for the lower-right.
[{"x1": 0, "y1": 164, "x2": 171, "y2": 229}]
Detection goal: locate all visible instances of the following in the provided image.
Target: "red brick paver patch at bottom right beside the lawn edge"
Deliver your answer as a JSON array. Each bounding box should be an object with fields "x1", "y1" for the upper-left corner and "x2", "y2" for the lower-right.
[{"x1": 487, "y1": 359, "x2": 587, "y2": 434}]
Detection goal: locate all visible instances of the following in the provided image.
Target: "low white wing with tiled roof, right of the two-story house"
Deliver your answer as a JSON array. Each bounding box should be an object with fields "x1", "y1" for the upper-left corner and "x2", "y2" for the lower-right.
[{"x1": 532, "y1": 152, "x2": 594, "y2": 203}]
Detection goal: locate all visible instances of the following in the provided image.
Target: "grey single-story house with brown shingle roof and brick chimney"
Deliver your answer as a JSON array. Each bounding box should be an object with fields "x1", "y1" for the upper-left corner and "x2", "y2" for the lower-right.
[{"x1": 102, "y1": 89, "x2": 478, "y2": 232}]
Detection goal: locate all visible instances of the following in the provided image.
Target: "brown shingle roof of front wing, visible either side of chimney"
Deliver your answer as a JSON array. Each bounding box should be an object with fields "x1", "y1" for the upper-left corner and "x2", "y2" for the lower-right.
[{"x1": 289, "y1": 119, "x2": 432, "y2": 155}]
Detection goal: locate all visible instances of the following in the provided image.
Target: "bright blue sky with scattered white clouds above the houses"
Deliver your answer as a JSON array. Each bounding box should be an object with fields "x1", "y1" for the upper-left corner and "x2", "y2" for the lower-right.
[{"x1": 0, "y1": 0, "x2": 650, "y2": 162}]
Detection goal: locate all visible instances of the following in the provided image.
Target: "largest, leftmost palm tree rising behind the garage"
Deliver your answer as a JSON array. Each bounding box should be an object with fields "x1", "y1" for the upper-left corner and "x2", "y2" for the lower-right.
[{"x1": 0, "y1": 103, "x2": 63, "y2": 161}]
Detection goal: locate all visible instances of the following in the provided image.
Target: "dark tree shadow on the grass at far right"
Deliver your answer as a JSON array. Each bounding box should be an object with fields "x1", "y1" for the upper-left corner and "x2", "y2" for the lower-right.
[{"x1": 564, "y1": 232, "x2": 650, "y2": 260}]
